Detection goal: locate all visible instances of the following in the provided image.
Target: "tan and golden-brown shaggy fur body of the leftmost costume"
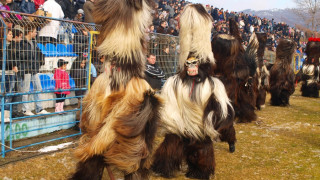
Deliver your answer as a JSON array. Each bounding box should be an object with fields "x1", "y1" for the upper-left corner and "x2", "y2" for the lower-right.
[{"x1": 75, "y1": 78, "x2": 161, "y2": 174}]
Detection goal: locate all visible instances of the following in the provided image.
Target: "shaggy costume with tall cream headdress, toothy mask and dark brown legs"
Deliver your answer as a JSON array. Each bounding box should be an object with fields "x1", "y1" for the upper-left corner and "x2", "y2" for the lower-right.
[{"x1": 152, "y1": 4, "x2": 235, "y2": 179}]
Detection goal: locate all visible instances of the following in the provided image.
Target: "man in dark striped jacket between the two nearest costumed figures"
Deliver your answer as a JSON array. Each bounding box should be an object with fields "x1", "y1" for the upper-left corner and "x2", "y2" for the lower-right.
[{"x1": 145, "y1": 54, "x2": 164, "y2": 90}]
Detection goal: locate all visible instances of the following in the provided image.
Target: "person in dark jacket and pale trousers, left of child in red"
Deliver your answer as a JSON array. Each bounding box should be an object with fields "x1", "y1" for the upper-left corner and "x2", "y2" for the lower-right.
[{"x1": 20, "y1": 26, "x2": 48, "y2": 116}]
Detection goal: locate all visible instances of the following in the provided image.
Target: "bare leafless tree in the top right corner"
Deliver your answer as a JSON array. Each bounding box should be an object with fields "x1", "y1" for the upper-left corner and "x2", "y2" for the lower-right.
[{"x1": 294, "y1": 0, "x2": 320, "y2": 32}]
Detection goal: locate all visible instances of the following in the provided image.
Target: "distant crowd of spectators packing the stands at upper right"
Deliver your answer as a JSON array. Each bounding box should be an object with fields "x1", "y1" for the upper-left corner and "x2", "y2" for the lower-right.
[{"x1": 149, "y1": 0, "x2": 306, "y2": 51}]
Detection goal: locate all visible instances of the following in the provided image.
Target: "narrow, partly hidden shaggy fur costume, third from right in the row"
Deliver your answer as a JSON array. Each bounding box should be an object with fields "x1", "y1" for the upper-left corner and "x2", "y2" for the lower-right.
[{"x1": 256, "y1": 33, "x2": 270, "y2": 110}]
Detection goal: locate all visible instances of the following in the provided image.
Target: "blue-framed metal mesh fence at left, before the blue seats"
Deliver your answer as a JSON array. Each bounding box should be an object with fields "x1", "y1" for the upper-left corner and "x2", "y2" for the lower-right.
[{"x1": 0, "y1": 11, "x2": 99, "y2": 157}]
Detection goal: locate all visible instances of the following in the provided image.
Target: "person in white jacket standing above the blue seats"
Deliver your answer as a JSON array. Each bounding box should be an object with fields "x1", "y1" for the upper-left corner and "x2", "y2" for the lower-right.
[{"x1": 39, "y1": 0, "x2": 64, "y2": 45}]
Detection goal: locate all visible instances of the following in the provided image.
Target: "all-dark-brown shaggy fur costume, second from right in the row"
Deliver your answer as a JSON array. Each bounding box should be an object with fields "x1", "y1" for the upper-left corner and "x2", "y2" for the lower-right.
[{"x1": 270, "y1": 39, "x2": 296, "y2": 106}]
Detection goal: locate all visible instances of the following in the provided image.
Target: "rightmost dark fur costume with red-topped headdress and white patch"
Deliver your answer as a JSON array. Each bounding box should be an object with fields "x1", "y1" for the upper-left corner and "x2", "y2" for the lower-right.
[{"x1": 299, "y1": 38, "x2": 320, "y2": 98}]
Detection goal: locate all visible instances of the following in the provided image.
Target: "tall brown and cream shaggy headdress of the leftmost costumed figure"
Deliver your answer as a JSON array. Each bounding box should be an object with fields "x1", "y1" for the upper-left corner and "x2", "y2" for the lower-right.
[{"x1": 93, "y1": 0, "x2": 152, "y2": 90}]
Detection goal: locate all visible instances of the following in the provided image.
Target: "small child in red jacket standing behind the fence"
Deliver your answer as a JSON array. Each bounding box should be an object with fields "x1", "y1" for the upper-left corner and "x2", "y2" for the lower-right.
[{"x1": 54, "y1": 59, "x2": 70, "y2": 112}]
